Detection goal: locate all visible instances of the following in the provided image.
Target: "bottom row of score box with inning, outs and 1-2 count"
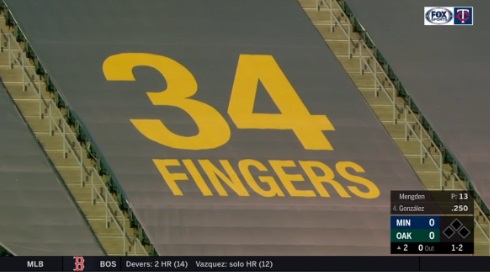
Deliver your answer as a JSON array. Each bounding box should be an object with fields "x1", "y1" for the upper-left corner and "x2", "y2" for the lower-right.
[{"x1": 391, "y1": 243, "x2": 474, "y2": 255}]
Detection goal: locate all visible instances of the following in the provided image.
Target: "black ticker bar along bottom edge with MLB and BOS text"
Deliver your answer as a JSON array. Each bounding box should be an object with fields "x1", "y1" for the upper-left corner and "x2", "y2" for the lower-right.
[{"x1": 0, "y1": 256, "x2": 490, "y2": 272}]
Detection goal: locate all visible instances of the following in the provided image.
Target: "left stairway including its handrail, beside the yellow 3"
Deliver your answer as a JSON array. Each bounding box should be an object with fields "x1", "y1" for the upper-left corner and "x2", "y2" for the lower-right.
[{"x1": 0, "y1": 12, "x2": 148, "y2": 256}]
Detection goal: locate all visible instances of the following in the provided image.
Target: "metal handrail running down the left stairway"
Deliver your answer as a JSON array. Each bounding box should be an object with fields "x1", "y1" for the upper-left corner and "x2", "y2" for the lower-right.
[{"x1": 0, "y1": 30, "x2": 147, "y2": 255}]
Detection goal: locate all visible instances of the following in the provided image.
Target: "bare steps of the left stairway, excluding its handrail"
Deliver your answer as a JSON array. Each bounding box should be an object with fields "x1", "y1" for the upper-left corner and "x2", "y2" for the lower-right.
[{"x1": 0, "y1": 11, "x2": 148, "y2": 256}]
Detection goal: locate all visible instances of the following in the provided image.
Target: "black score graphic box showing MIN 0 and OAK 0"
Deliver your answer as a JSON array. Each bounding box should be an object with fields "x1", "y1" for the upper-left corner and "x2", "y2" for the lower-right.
[{"x1": 391, "y1": 191, "x2": 474, "y2": 254}]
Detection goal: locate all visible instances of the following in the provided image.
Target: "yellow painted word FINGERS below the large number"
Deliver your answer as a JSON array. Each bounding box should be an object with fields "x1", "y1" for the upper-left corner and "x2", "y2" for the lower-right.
[{"x1": 153, "y1": 159, "x2": 380, "y2": 199}]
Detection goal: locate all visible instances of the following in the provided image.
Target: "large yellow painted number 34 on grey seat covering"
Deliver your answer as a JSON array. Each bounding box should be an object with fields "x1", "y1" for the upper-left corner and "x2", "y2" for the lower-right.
[{"x1": 103, "y1": 53, "x2": 334, "y2": 150}]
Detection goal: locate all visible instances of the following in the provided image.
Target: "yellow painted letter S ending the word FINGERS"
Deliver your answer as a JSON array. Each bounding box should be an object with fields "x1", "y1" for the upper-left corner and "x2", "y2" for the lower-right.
[{"x1": 335, "y1": 161, "x2": 380, "y2": 199}]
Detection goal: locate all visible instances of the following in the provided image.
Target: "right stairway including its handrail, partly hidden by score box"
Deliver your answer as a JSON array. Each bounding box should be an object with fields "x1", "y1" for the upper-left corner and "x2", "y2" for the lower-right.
[{"x1": 299, "y1": 0, "x2": 490, "y2": 256}]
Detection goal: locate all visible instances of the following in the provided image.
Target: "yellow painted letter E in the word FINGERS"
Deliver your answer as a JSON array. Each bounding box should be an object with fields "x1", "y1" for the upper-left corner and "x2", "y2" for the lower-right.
[{"x1": 269, "y1": 160, "x2": 316, "y2": 197}]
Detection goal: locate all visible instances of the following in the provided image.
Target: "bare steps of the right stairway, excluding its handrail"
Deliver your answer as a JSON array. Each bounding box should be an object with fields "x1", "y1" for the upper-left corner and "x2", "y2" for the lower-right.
[{"x1": 298, "y1": 0, "x2": 490, "y2": 256}]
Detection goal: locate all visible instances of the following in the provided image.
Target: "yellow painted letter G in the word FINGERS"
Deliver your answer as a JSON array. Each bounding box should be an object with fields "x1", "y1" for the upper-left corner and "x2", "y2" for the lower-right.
[{"x1": 238, "y1": 159, "x2": 284, "y2": 197}]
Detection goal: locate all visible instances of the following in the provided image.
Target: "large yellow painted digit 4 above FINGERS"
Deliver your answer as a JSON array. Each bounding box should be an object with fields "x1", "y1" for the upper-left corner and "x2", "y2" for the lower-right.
[{"x1": 228, "y1": 55, "x2": 335, "y2": 150}]
